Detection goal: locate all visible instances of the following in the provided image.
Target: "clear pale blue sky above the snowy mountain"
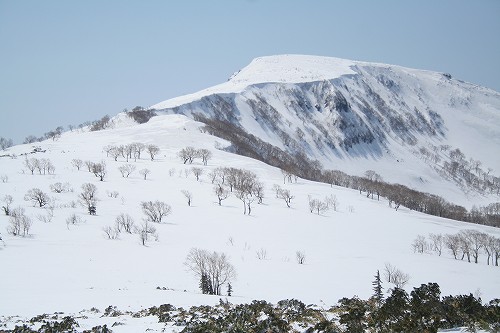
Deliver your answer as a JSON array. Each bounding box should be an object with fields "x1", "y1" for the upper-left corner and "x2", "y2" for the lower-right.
[{"x1": 0, "y1": 0, "x2": 500, "y2": 143}]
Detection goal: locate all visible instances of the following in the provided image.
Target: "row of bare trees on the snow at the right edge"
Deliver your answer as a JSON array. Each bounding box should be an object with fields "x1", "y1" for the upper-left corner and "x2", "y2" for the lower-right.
[{"x1": 412, "y1": 229, "x2": 500, "y2": 266}]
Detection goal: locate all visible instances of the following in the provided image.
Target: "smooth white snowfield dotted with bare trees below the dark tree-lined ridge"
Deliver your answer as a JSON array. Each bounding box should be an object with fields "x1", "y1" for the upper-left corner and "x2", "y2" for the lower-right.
[{"x1": 0, "y1": 115, "x2": 500, "y2": 332}]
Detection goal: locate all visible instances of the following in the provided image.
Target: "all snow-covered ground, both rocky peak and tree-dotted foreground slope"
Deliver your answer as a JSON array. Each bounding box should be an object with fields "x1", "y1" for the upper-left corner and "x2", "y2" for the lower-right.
[{"x1": 0, "y1": 56, "x2": 500, "y2": 332}]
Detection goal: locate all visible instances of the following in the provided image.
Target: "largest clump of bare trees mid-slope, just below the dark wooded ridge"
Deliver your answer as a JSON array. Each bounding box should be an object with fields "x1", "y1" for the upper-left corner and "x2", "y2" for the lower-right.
[{"x1": 209, "y1": 167, "x2": 264, "y2": 215}]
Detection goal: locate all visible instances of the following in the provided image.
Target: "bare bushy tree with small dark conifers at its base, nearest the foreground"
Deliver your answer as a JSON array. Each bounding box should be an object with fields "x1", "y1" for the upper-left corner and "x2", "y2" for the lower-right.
[{"x1": 185, "y1": 248, "x2": 236, "y2": 295}]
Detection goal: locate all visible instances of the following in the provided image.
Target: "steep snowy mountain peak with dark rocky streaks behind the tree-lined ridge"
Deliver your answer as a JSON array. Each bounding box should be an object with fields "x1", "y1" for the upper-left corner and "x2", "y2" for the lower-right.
[{"x1": 153, "y1": 55, "x2": 500, "y2": 208}]
